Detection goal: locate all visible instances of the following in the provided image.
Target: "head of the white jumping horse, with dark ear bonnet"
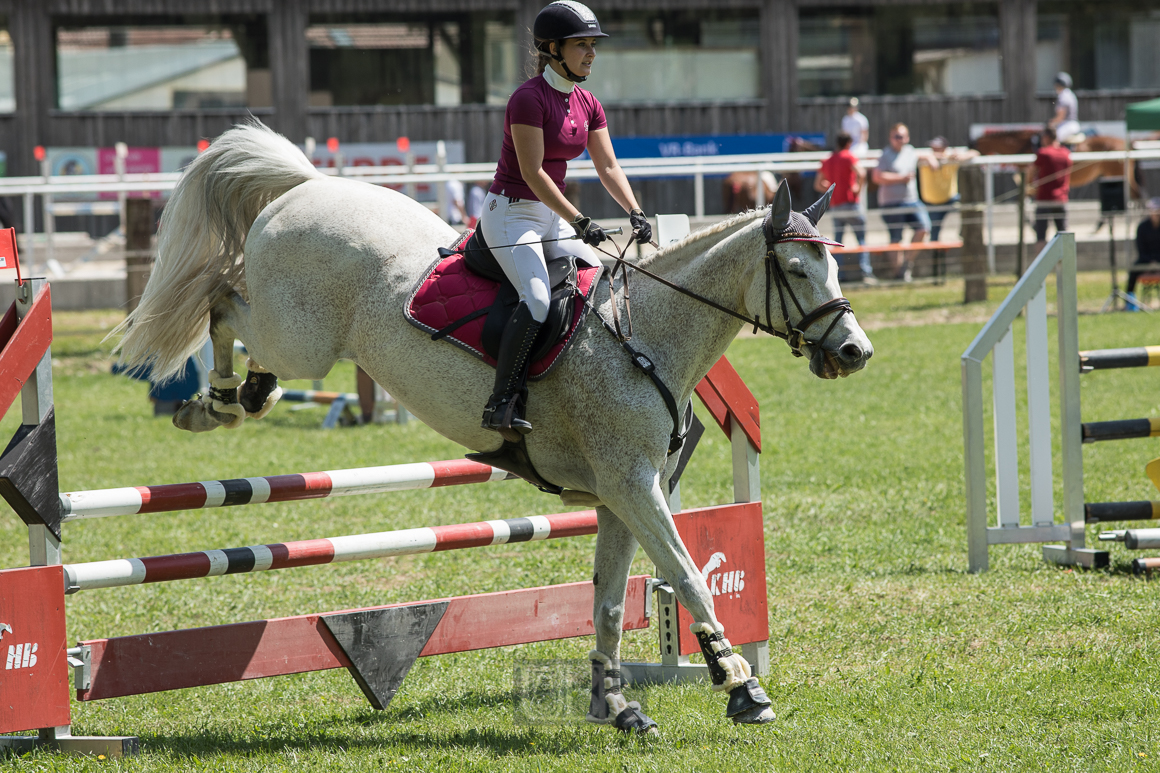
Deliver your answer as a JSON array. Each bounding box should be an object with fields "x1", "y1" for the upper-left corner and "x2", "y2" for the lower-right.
[{"x1": 745, "y1": 177, "x2": 873, "y2": 378}]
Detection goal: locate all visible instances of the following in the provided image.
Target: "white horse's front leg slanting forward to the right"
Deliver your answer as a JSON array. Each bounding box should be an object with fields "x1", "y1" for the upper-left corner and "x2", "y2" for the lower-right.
[{"x1": 599, "y1": 469, "x2": 774, "y2": 724}]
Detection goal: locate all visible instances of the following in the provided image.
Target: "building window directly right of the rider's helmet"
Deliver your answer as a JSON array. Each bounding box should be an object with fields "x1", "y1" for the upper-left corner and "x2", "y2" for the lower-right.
[{"x1": 585, "y1": 10, "x2": 761, "y2": 103}]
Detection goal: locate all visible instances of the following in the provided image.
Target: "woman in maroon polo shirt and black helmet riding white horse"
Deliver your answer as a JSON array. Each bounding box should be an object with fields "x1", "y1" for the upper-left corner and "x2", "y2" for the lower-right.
[{"x1": 479, "y1": 0, "x2": 652, "y2": 435}]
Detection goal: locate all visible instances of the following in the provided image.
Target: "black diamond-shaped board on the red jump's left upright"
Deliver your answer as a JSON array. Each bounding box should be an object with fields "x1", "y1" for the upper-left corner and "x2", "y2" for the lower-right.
[{"x1": 0, "y1": 409, "x2": 60, "y2": 540}]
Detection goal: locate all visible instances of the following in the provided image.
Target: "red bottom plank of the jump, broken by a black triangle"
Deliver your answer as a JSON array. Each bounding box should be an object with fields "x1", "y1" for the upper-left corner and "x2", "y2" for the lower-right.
[{"x1": 77, "y1": 575, "x2": 648, "y2": 701}]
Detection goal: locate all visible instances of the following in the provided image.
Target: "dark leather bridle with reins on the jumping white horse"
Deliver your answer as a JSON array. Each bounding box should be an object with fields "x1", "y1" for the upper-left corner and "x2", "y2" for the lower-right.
[{"x1": 597, "y1": 210, "x2": 854, "y2": 357}]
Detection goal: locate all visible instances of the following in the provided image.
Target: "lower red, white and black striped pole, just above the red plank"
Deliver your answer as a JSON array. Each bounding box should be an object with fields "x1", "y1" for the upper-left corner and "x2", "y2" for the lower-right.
[{"x1": 64, "y1": 510, "x2": 596, "y2": 593}]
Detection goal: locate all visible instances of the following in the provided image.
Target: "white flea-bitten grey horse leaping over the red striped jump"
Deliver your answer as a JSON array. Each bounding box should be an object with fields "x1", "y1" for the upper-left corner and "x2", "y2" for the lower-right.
[{"x1": 118, "y1": 122, "x2": 872, "y2": 732}]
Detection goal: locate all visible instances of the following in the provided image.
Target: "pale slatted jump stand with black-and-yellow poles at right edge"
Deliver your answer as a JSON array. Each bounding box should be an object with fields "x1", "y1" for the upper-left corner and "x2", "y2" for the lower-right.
[{"x1": 963, "y1": 233, "x2": 1160, "y2": 571}]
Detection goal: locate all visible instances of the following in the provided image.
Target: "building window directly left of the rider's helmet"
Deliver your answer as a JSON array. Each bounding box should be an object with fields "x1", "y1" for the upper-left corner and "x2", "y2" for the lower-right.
[{"x1": 306, "y1": 14, "x2": 519, "y2": 107}]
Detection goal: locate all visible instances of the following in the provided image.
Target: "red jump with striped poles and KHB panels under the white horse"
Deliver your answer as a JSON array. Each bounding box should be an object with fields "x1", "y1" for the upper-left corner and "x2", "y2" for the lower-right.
[{"x1": 0, "y1": 280, "x2": 769, "y2": 756}]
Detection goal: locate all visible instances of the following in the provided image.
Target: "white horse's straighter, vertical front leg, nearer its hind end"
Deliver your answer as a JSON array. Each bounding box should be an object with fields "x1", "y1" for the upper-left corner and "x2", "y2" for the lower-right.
[{"x1": 587, "y1": 506, "x2": 657, "y2": 735}]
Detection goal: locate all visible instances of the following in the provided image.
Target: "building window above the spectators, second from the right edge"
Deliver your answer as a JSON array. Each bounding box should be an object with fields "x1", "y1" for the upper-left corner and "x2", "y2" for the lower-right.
[{"x1": 798, "y1": 2, "x2": 1002, "y2": 96}]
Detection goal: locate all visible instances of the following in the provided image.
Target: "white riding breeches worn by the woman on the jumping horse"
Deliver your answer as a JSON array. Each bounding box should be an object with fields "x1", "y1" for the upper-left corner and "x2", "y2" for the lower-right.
[{"x1": 479, "y1": 193, "x2": 600, "y2": 323}]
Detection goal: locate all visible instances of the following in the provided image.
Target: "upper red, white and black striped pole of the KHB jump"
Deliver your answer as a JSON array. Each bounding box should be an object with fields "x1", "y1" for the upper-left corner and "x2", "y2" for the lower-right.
[{"x1": 60, "y1": 458, "x2": 516, "y2": 522}]
